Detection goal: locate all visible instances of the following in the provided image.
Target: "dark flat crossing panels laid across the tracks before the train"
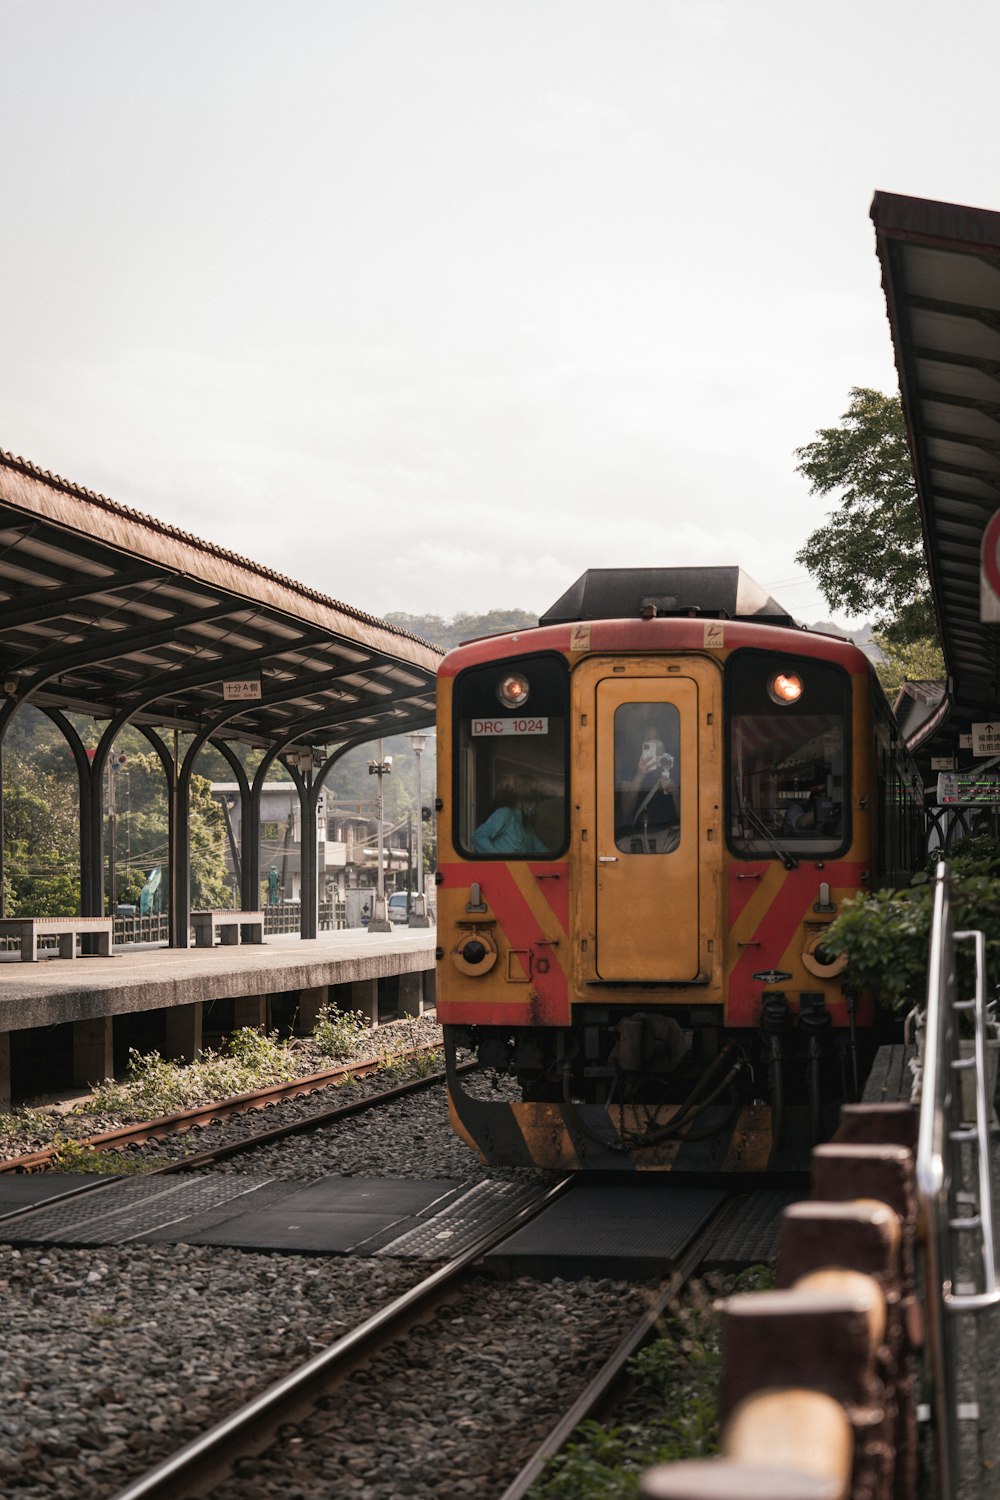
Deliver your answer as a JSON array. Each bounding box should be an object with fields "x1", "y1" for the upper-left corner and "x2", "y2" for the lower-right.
[{"x1": 0, "y1": 1173, "x2": 807, "y2": 1280}]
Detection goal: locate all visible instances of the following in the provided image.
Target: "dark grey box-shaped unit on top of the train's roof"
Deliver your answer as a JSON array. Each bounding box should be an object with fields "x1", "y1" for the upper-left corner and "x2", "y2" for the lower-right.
[{"x1": 538, "y1": 567, "x2": 796, "y2": 627}]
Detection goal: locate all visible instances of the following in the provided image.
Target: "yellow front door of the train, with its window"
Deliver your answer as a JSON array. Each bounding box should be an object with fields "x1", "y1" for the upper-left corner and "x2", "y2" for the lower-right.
[{"x1": 595, "y1": 675, "x2": 700, "y2": 981}]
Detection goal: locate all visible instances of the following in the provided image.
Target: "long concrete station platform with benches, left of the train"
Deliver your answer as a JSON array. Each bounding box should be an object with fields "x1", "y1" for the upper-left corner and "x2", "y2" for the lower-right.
[{"x1": 0, "y1": 927, "x2": 435, "y2": 1110}]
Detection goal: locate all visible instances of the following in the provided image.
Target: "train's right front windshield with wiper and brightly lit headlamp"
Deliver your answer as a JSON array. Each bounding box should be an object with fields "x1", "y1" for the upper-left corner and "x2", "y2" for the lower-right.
[{"x1": 727, "y1": 651, "x2": 850, "y2": 858}]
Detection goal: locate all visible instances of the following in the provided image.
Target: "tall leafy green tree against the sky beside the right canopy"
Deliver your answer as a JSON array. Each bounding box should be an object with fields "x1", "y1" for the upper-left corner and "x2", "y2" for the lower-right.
[{"x1": 796, "y1": 386, "x2": 937, "y2": 645}]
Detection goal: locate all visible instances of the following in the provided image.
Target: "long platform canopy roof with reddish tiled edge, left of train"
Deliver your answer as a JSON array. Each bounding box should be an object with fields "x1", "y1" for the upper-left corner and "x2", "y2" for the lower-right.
[{"x1": 0, "y1": 452, "x2": 441, "y2": 746}]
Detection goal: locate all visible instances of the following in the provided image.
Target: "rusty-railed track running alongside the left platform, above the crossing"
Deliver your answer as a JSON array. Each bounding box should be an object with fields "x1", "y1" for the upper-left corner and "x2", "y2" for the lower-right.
[{"x1": 0, "y1": 1043, "x2": 458, "y2": 1175}]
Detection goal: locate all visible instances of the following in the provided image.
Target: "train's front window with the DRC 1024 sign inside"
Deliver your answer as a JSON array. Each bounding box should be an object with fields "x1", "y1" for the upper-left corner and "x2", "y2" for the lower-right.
[{"x1": 454, "y1": 657, "x2": 570, "y2": 860}]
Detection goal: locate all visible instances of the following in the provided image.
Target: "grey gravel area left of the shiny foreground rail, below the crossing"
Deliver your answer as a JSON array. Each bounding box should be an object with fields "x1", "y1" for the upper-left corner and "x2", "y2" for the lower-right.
[{"x1": 0, "y1": 1245, "x2": 426, "y2": 1500}]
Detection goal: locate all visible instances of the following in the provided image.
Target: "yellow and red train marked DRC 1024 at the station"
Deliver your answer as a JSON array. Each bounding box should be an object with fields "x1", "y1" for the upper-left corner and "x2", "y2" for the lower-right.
[{"x1": 438, "y1": 569, "x2": 924, "y2": 1170}]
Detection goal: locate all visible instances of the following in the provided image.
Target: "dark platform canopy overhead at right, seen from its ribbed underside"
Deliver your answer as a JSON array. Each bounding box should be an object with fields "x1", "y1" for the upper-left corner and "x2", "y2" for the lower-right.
[{"x1": 871, "y1": 192, "x2": 1000, "y2": 734}]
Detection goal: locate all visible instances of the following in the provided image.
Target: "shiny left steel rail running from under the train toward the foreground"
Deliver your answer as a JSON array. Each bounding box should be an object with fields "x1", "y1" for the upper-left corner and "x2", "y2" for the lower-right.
[{"x1": 111, "y1": 1178, "x2": 573, "y2": 1500}]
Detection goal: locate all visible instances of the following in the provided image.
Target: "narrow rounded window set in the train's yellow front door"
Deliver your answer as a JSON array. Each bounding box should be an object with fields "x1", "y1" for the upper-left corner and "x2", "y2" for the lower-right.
[{"x1": 615, "y1": 704, "x2": 681, "y2": 854}]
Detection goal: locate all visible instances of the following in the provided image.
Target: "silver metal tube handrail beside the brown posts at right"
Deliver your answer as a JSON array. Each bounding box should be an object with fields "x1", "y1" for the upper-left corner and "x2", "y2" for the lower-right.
[{"x1": 916, "y1": 864, "x2": 1000, "y2": 1496}]
